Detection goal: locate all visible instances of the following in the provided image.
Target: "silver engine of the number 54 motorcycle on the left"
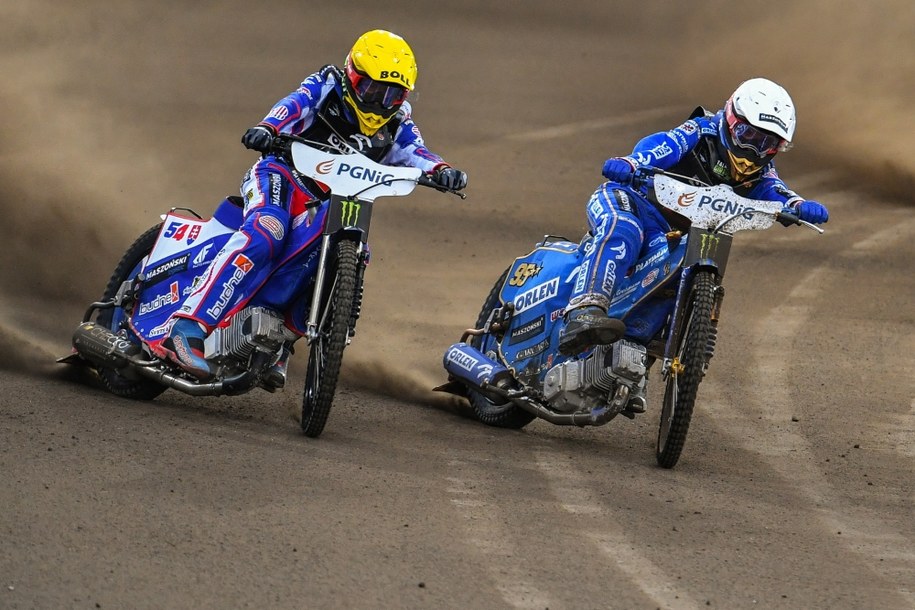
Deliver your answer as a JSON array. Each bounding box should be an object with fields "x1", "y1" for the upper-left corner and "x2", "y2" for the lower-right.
[{"x1": 206, "y1": 307, "x2": 295, "y2": 362}]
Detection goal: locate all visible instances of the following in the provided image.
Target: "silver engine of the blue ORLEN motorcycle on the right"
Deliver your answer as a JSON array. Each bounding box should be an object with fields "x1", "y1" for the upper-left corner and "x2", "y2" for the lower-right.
[{"x1": 543, "y1": 339, "x2": 648, "y2": 413}]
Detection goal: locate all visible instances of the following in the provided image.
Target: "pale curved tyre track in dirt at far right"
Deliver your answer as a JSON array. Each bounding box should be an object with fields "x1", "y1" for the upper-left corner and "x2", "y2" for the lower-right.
[{"x1": 705, "y1": 193, "x2": 915, "y2": 607}]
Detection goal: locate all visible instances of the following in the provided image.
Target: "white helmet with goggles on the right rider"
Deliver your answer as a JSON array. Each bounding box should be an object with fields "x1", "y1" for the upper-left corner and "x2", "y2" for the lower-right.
[{"x1": 718, "y1": 78, "x2": 797, "y2": 180}]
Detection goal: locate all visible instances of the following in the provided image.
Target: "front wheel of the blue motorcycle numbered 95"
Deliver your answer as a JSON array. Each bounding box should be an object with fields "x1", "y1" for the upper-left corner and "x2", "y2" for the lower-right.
[{"x1": 656, "y1": 271, "x2": 717, "y2": 468}]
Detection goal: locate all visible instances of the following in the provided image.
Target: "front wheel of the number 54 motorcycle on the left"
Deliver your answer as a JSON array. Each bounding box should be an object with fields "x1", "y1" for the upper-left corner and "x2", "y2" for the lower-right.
[{"x1": 302, "y1": 240, "x2": 359, "y2": 438}]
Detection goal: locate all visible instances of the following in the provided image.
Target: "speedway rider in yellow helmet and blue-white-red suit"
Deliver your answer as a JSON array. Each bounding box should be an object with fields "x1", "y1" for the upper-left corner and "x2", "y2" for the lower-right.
[{"x1": 161, "y1": 30, "x2": 467, "y2": 380}]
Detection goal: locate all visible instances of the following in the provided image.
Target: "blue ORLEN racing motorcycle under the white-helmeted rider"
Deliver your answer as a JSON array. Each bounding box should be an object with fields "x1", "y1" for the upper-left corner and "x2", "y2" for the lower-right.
[{"x1": 435, "y1": 168, "x2": 823, "y2": 468}]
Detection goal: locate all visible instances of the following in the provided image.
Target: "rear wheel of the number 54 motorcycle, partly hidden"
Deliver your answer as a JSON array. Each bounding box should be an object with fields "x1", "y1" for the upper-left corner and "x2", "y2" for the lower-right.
[{"x1": 95, "y1": 224, "x2": 166, "y2": 400}]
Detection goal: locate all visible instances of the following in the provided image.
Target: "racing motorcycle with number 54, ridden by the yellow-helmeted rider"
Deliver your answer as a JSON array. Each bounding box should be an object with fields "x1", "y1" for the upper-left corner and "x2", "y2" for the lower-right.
[{"x1": 58, "y1": 135, "x2": 464, "y2": 437}]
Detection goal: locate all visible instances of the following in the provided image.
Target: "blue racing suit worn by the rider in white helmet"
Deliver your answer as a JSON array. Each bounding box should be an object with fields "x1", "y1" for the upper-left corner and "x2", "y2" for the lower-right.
[{"x1": 568, "y1": 108, "x2": 802, "y2": 311}]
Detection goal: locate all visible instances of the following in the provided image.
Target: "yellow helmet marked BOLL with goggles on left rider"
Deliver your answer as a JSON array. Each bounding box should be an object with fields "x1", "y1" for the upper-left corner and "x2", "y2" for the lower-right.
[{"x1": 343, "y1": 30, "x2": 416, "y2": 136}]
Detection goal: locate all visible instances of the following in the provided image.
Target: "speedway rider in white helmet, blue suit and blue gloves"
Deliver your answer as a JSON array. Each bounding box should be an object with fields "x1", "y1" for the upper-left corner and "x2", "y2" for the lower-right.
[{"x1": 559, "y1": 78, "x2": 829, "y2": 355}]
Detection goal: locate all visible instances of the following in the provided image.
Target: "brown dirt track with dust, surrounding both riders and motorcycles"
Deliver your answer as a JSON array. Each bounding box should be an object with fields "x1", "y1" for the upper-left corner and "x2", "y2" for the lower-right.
[{"x1": 0, "y1": 0, "x2": 915, "y2": 610}]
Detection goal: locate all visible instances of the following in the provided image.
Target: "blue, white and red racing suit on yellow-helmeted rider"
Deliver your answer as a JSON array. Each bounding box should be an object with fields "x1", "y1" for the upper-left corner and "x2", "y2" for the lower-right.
[{"x1": 175, "y1": 66, "x2": 445, "y2": 333}]
